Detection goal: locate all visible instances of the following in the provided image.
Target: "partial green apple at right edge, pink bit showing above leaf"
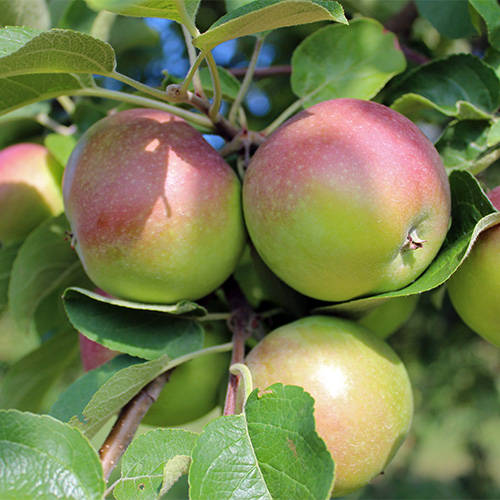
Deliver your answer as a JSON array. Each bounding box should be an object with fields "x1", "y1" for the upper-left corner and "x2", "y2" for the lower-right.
[{"x1": 447, "y1": 186, "x2": 500, "y2": 347}]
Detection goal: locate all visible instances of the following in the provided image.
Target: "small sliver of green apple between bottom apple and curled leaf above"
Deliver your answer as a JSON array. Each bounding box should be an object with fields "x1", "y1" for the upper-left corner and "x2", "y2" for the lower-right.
[{"x1": 358, "y1": 295, "x2": 419, "y2": 339}]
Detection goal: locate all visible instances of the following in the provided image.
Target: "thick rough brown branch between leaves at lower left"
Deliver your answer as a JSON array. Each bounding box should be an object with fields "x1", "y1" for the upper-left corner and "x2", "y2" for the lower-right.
[{"x1": 99, "y1": 370, "x2": 172, "y2": 481}]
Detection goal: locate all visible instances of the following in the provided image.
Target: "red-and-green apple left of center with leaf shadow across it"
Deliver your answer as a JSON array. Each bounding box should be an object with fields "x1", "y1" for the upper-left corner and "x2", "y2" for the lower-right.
[{"x1": 63, "y1": 109, "x2": 246, "y2": 304}]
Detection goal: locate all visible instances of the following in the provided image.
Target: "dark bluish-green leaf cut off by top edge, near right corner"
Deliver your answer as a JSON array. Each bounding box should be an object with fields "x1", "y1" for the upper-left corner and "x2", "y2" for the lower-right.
[{"x1": 415, "y1": 0, "x2": 476, "y2": 38}]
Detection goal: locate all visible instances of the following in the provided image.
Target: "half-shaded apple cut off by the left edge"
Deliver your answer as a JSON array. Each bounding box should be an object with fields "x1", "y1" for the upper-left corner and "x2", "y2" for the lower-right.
[{"x1": 0, "y1": 143, "x2": 63, "y2": 243}]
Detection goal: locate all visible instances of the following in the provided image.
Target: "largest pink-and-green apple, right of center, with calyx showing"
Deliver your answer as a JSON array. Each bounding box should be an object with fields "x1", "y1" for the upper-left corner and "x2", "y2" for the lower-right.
[{"x1": 243, "y1": 99, "x2": 451, "y2": 302}]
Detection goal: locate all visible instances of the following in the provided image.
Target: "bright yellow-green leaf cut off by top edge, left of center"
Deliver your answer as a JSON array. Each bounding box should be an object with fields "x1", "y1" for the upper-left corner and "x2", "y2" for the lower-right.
[{"x1": 85, "y1": 0, "x2": 201, "y2": 24}]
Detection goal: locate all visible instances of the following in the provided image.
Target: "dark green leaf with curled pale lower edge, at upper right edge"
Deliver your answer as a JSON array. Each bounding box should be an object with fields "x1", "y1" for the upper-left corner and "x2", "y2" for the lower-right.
[{"x1": 390, "y1": 54, "x2": 500, "y2": 120}]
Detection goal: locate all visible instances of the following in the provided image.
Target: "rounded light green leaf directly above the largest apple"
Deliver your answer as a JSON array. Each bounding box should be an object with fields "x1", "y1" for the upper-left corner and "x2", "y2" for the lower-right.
[{"x1": 291, "y1": 19, "x2": 406, "y2": 106}]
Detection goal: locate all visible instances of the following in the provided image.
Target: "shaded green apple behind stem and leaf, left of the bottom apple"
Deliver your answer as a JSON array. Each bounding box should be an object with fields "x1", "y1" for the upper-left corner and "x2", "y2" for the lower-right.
[{"x1": 143, "y1": 321, "x2": 231, "y2": 427}]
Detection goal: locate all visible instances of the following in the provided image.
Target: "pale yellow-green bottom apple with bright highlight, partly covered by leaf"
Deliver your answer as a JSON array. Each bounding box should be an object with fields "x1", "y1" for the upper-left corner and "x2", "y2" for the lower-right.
[{"x1": 245, "y1": 316, "x2": 413, "y2": 496}]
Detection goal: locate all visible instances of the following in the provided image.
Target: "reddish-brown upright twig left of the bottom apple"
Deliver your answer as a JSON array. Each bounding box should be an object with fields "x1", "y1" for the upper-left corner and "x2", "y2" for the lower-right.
[{"x1": 223, "y1": 278, "x2": 260, "y2": 415}]
